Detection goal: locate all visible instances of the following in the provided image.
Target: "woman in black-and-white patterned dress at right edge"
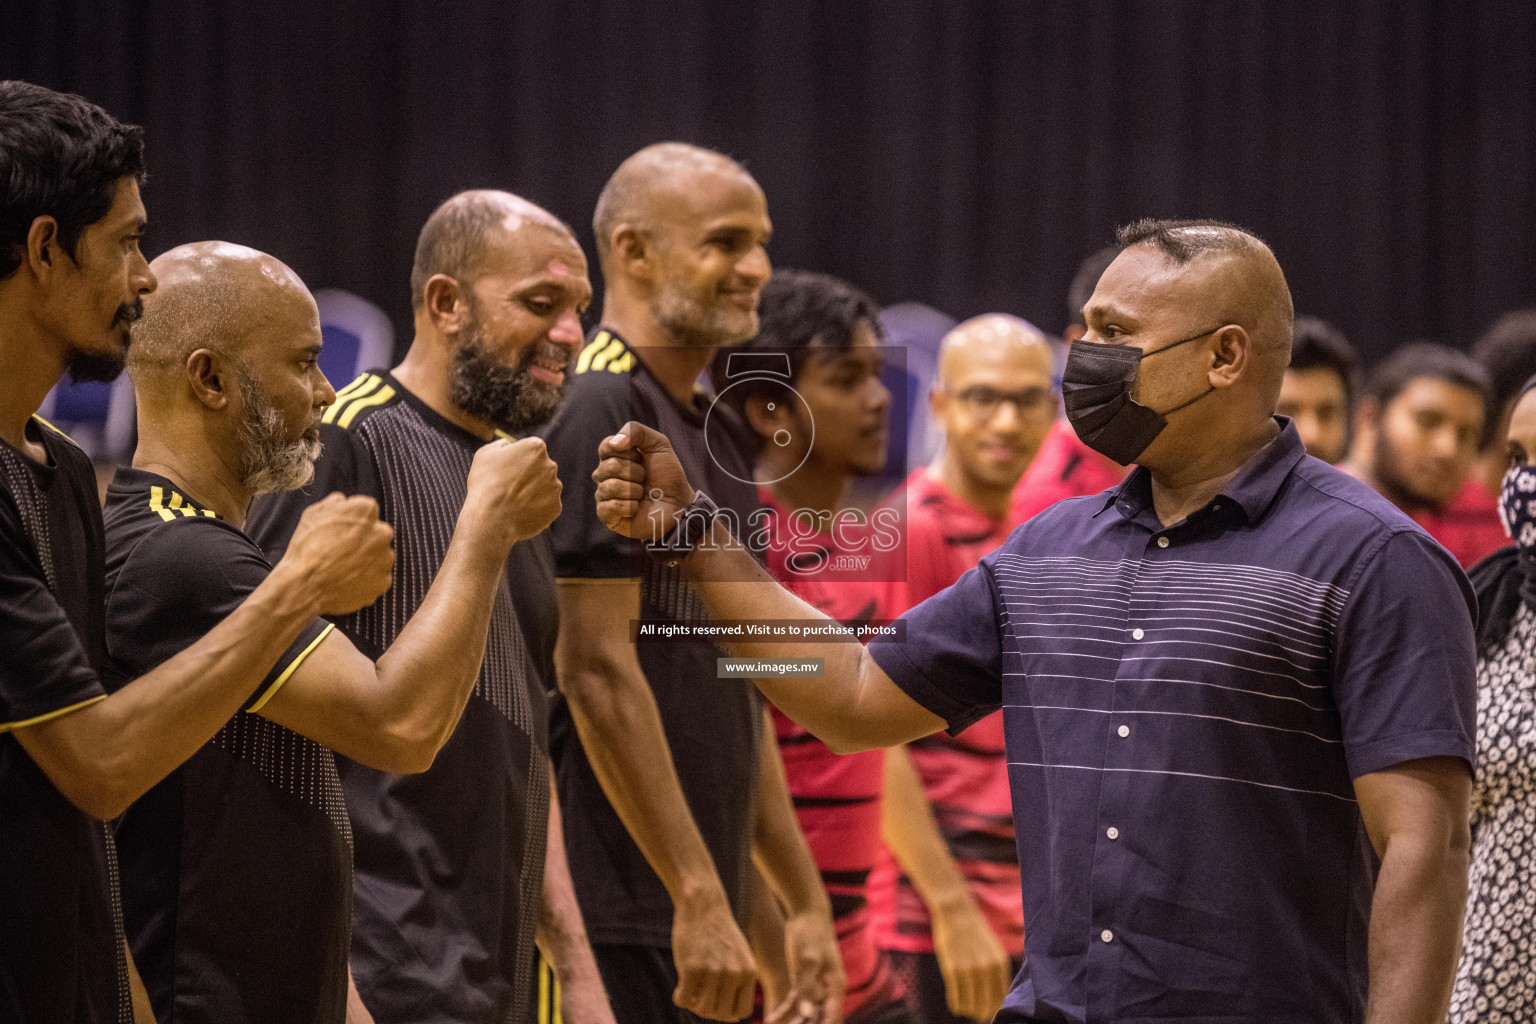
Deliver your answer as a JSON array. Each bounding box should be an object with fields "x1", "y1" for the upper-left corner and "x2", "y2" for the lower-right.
[{"x1": 1450, "y1": 378, "x2": 1536, "y2": 1024}]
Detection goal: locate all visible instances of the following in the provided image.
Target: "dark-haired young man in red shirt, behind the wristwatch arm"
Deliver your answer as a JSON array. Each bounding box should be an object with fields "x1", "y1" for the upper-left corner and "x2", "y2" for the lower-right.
[{"x1": 710, "y1": 270, "x2": 912, "y2": 1024}]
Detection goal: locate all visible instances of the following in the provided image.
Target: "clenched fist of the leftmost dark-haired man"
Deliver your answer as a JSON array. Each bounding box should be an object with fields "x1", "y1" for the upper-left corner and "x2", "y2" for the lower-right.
[{"x1": 283, "y1": 494, "x2": 395, "y2": 616}]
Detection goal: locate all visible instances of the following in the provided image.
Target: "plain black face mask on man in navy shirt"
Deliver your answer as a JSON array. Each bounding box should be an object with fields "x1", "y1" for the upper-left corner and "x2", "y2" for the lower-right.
[{"x1": 1061, "y1": 327, "x2": 1221, "y2": 465}]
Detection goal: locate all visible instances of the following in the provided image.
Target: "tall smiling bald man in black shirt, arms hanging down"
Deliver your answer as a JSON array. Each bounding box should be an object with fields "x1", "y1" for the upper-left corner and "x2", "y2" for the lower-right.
[{"x1": 545, "y1": 143, "x2": 843, "y2": 1024}]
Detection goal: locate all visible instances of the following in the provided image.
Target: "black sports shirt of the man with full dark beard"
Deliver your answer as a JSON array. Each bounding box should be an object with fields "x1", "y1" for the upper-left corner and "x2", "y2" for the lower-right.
[{"x1": 250, "y1": 370, "x2": 554, "y2": 1024}]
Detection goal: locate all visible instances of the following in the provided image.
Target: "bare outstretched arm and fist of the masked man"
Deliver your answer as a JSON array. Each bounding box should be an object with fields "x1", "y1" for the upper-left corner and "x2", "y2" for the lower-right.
[{"x1": 593, "y1": 422, "x2": 945, "y2": 754}]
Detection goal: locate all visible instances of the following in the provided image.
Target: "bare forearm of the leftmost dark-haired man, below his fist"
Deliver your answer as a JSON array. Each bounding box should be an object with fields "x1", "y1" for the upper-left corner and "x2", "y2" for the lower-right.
[{"x1": 27, "y1": 563, "x2": 318, "y2": 818}]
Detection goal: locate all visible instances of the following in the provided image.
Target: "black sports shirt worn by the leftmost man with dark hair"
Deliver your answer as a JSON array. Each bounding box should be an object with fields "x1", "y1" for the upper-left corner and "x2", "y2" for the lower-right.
[{"x1": 0, "y1": 418, "x2": 132, "y2": 1024}]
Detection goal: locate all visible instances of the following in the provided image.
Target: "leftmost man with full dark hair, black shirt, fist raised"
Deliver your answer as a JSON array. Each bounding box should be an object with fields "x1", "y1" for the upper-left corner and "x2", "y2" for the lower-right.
[{"x1": 0, "y1": 81, "x2": 393, "y2": 1024}]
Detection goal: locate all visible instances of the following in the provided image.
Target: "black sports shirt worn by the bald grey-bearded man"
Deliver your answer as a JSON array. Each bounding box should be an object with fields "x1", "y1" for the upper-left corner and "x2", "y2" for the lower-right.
[{"x1": 106, "y1": 468, "x2": 342, "y2": 1024}]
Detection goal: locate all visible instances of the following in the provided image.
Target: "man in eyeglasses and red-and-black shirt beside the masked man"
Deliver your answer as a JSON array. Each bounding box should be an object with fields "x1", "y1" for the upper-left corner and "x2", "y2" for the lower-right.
[{"x1": 869, "y1": 313, "x2": 1058, "y2": 1021}]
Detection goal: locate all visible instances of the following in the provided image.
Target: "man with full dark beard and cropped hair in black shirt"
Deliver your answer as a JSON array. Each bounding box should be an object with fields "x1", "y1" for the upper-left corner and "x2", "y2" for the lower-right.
[{"x1": 252, "y1": 190, "x2": 610, "y2": 1024}]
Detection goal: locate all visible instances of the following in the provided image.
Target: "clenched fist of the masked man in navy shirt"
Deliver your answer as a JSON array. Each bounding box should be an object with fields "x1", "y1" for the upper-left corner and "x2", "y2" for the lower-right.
[{"x1": 591, "y1": 419, "x2": 693, "y2": 540}]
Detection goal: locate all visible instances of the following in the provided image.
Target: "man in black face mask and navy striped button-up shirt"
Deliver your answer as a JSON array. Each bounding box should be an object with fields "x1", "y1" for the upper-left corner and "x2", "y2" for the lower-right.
[{"x1": 598, "y1": 221, "x2": 1476, "y2": 1024}]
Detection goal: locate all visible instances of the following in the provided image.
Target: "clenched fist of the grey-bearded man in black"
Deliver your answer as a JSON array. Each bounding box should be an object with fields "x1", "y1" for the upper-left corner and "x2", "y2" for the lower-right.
[{"x1": 464, "y1": 438, "x2": 561, "y2": 548}]
